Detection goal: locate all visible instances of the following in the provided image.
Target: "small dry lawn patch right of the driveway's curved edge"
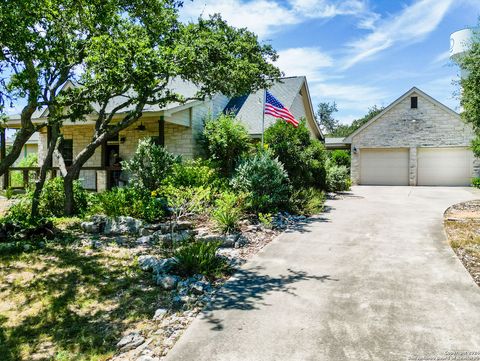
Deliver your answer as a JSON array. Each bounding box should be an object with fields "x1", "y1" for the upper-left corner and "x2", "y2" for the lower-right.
[{"x1": 445, "y1": 200, "x2": 480, "y2": 286}]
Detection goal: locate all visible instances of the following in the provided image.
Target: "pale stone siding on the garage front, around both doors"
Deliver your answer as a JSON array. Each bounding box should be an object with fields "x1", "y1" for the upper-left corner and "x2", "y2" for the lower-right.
[{"x1": 351, "y1": 93, "x2": 480, "y2": 185}]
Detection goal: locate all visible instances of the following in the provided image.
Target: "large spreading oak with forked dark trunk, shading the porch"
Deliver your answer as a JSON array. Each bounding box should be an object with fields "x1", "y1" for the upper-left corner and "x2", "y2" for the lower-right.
[{"x1": 0, "y1": 0, "x2": 280, "y2": 214}]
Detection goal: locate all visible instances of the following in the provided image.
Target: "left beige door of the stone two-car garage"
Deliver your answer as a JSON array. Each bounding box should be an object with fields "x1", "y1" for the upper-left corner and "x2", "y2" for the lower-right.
[{"x1": 360, "y1": 148, "x2": 408, "y2": 186}]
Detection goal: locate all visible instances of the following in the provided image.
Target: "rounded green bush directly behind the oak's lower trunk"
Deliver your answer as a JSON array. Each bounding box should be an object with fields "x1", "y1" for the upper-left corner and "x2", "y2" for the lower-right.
[{"x1": 38, "y1": 177, "x2": 90, "y2": 217}]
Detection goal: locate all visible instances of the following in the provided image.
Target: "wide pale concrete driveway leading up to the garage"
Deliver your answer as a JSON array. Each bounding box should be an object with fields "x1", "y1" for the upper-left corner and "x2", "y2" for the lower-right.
[{"x1": 167, "y1": 187, "x2": 480, "y2": 361}]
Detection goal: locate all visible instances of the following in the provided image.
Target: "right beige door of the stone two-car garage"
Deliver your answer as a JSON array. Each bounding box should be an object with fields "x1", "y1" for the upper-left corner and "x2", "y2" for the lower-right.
[{"x1": 417, "y1": 148, "x2": 473, "y2": 186}]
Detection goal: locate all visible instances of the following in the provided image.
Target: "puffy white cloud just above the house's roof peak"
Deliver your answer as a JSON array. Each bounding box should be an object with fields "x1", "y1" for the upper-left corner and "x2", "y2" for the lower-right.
[{"x1": 275, "y1": 48, "x2": 333, "y2": 82}]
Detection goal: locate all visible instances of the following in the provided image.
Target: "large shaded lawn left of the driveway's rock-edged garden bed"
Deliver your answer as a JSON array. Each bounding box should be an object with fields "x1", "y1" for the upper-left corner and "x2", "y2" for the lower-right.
[{"x1": 0, "y1": 229, "x2": 167, "y2": 361}]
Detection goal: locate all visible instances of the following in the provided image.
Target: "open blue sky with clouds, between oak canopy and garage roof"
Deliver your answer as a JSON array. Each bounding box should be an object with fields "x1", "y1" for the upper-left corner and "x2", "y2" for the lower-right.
[{"x1": 182, "y1": 0, "x2": 480, "y2": 123}]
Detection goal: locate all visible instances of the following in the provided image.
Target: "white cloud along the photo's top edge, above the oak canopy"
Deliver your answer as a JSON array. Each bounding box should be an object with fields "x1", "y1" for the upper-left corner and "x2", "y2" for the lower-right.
[{"x1": 180, "y1": 0, "x2": 371, "y2": 38}]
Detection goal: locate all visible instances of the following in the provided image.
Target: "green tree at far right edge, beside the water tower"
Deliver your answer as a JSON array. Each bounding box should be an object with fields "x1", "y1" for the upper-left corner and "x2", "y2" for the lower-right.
[{"x1": 456, "y1": 27, "x2": 480, "y2": 157}]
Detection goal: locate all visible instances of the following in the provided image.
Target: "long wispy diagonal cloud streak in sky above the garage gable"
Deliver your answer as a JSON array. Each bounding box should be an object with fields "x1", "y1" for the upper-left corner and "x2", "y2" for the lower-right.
[{"x1": 343, "y1": 0, "x2": 453, "y2": 69}]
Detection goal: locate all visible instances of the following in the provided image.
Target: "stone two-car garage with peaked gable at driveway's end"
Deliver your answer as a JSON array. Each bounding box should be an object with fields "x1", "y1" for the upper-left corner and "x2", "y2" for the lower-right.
[{"x1": 345, "y1": 87, "x2": 480, "y2": 186}]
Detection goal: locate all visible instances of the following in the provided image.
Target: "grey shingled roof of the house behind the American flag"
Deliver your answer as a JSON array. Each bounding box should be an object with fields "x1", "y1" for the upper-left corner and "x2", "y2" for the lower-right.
[{"x1": 224, "y1": 76, "x2": 323, "y2": 138}]
